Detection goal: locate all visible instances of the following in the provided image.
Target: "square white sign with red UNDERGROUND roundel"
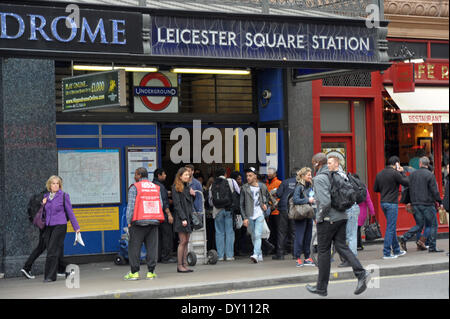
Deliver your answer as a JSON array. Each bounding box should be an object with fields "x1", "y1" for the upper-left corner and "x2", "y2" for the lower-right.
[{"x1": 133, "y1": 72, "x2": 178, "y2": 113}]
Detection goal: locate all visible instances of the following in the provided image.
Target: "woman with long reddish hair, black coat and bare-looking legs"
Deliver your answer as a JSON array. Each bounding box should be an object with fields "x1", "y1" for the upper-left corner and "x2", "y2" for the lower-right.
[{"x1": 172, "y1": 167, "x2": 194, "y2": 273}]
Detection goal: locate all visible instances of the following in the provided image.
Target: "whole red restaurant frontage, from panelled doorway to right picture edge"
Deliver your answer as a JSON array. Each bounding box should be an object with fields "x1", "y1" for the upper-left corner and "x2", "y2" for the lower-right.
[{"x1": 312, "y1": 60, "x2": 449, "y2": 239}]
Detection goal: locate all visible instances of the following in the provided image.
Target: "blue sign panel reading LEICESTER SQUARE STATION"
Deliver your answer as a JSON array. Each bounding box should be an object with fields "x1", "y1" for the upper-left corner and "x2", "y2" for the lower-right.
[{"x1": 151, "y1": 16, "x2": 377, "y2": 63}]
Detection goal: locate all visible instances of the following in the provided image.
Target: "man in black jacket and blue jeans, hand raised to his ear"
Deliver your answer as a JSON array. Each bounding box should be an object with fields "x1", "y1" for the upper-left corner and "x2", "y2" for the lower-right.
[{"x1": 374, "y1": 156, "x2": 409, "y2": 259}]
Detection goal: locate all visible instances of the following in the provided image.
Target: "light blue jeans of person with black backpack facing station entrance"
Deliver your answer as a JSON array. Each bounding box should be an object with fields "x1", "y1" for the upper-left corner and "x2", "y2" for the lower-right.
[{"x1": 214, "y1": 209, "x2": 234, "y2": 258}]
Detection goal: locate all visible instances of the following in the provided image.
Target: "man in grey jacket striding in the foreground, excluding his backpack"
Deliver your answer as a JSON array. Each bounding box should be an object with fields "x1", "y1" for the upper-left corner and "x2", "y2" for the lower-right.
[{"x1": 306, "y1": 153, "x2": 369, "y2": 296}]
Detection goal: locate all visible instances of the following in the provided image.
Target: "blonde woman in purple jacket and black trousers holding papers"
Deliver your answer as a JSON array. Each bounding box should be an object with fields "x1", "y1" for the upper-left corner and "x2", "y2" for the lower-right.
[{"x1": 42, "y1": 176, "x2": 80, "y2": 282}]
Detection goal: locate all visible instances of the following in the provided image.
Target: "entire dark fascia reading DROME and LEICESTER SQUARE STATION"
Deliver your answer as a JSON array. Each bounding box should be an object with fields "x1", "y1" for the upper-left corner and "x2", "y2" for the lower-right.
[{"x1": 0, "y1": 4, "x2": 388, "y2": 67}]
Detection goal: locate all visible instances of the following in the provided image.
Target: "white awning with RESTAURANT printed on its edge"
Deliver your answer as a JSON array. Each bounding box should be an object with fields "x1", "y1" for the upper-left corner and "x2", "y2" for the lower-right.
[{"x1": 385, "y1": 86, "x2": 449, "y2": 124}]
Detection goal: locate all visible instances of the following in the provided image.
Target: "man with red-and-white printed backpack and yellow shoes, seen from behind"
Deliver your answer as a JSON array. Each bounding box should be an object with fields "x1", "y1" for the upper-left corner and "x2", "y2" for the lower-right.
[{"x1": 124, "y1": 167, "x2": 164, "y2": 280}]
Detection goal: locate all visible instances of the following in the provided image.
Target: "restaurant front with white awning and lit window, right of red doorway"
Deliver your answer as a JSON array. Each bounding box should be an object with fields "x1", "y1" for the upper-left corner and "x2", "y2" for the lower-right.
[{"x1": 381, "y1": 58, "x2": 449, "y2": 235}]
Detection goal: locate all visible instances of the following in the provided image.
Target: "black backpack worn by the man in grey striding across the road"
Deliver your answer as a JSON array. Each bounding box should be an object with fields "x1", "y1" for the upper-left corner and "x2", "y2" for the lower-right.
[{"x1": 328, "y1": 172, "x2": 356, "y2": 212}]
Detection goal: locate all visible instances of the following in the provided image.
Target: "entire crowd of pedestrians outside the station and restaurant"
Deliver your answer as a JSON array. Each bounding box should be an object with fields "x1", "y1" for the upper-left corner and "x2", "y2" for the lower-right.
[{"x1": 21, "y1": 153, "x2": 449, "y2": 296}]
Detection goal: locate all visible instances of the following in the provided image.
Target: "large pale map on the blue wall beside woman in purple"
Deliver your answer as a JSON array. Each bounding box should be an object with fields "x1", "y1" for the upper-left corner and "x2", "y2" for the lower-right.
[{"x1": 58, "y1": 149, "x2": 121, "y2": 205}]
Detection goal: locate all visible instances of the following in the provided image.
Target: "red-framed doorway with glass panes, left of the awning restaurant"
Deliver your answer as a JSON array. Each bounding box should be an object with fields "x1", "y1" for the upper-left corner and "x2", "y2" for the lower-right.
[{"x1": 312, "y1": 72, "x2": 385, "y2": 234}]
